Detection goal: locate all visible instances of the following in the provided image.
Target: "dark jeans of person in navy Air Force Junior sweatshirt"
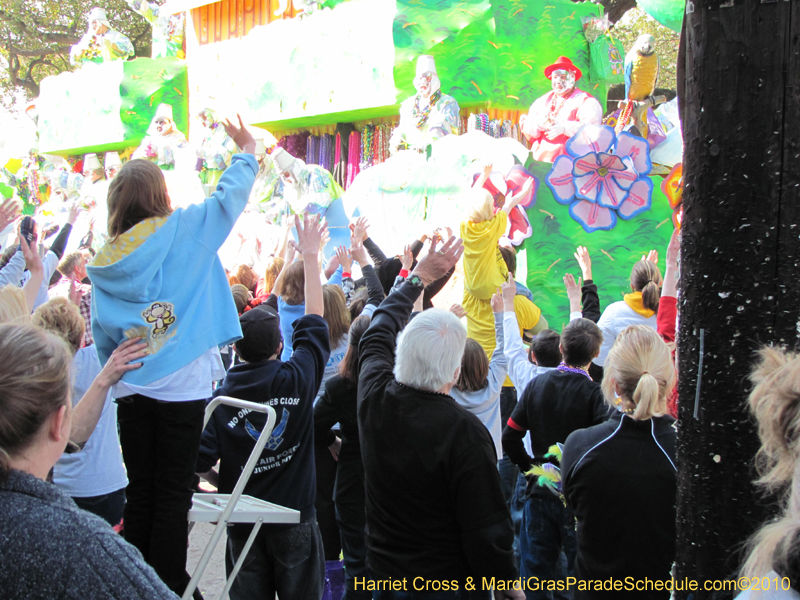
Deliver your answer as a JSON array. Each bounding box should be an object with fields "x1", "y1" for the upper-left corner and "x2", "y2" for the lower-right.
[{"x1": 225, "y1": 517, "x2": 325, "y2": 600}]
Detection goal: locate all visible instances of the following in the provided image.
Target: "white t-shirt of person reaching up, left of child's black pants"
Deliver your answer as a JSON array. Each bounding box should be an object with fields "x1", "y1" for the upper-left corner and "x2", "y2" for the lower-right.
[{"x1": 53, "y1": 345, "x2": 128, "y2": 498}]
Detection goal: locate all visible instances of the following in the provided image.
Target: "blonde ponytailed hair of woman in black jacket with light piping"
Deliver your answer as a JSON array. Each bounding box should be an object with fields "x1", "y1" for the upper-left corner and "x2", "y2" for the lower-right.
[{"x1": 603, "y1": 325, "x2": 675, "y2": 421}]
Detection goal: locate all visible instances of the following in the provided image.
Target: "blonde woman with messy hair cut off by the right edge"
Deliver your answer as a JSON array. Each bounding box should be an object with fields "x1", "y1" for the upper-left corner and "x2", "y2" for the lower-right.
[{"x1": 737, "y1": 348, "x2": 800, "y2": 600}]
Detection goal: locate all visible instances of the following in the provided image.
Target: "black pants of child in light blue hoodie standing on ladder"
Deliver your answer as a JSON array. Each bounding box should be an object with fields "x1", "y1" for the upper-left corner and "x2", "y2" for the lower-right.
[{"x1": 117, "y1": 395, "x2": 206, "y2": 595}]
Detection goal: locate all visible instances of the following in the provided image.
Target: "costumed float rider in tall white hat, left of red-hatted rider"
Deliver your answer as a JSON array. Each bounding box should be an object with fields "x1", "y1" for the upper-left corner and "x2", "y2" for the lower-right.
[{"x1": 389, "y1": 55, "x2": 460, "y2": 152}]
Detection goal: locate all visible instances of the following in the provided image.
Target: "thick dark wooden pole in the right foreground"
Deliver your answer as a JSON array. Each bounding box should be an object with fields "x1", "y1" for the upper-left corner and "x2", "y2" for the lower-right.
[{"x1": 676, "y1": 0, "x2": 800, "y2": 599}]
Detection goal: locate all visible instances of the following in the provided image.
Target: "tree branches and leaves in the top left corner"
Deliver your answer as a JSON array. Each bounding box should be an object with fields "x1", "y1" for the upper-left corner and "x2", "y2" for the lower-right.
[{"x1": 0, "y1": 0, "x2": 151, "y2": 103}]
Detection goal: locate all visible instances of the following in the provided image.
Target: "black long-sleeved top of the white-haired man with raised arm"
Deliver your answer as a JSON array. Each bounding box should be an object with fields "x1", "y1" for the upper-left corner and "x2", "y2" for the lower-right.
[{"x1": 358, "y1": 282, "x2": 516, "y2": 589}]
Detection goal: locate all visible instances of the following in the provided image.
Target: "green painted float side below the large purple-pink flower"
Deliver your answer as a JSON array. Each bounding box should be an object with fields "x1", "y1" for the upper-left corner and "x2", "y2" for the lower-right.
[{"x1": 524, "y1": 162, "x2": 672, "y2": 331}]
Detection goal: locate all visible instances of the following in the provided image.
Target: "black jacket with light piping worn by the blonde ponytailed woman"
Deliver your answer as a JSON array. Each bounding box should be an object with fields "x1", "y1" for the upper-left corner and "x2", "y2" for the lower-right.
[{"x1": 561, "y1": 411, "x2": 677, "y2": 599}]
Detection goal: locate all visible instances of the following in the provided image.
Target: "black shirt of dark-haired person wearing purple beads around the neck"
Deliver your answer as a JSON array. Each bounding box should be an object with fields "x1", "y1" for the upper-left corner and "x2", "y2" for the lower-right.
[{"x1": 503, "y1": 370, "x2": 610, "y2": 496}]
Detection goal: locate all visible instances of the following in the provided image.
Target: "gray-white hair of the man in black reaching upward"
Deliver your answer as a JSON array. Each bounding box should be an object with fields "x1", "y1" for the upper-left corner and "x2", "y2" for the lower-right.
[{"x1": 394, "y1": 308, "x2": 467, "y2": 392}]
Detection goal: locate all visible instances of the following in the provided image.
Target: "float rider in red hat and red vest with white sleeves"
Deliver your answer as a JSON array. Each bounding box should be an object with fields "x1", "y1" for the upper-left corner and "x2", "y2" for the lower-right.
[{"x1": 519, "y1": 56, "x2": 603, "y2": 162}]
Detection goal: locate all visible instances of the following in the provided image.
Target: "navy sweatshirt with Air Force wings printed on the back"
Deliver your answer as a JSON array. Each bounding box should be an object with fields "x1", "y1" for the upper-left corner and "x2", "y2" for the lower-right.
[{"x1": 197, "y1": 315, "x2": 331, "y2": 521}]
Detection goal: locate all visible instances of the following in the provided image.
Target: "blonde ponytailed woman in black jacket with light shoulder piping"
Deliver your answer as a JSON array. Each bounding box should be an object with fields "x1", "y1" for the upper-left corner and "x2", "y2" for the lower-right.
[{"x1": 561, "y1": 325, "x2": 677, "y2": 600}]
